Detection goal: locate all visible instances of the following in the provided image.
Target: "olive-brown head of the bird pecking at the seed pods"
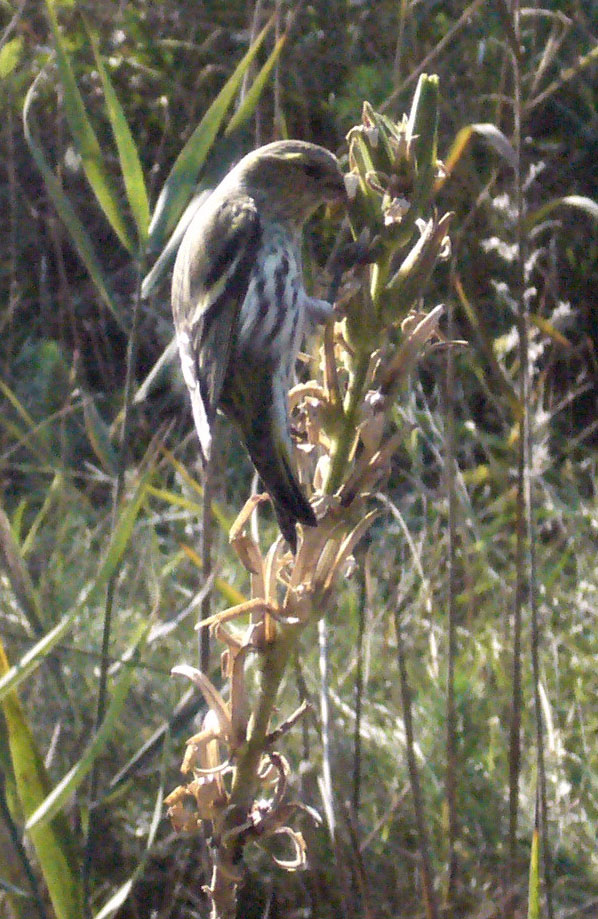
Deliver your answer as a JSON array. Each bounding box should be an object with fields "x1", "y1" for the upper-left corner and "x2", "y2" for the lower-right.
[{"x1": 231, "y1": 140, "x2": 346, "y2": 226}]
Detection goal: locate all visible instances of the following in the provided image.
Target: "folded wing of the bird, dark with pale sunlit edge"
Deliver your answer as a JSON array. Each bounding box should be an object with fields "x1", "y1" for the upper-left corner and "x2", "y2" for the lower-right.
[{"x1": 172, "y1": 193, "x2": 261, "y2": 460}]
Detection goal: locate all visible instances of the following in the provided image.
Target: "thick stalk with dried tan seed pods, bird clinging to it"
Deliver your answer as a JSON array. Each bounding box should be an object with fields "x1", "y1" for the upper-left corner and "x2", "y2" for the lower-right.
[{"x1": 166, "y1": 75, "x2": 450, "y2": 919}]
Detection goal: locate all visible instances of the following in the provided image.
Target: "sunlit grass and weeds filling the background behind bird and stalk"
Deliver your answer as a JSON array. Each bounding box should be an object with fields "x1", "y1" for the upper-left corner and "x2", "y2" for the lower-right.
[{"x1": 0, "y1": 0, "x2": 598, "y2": 919}]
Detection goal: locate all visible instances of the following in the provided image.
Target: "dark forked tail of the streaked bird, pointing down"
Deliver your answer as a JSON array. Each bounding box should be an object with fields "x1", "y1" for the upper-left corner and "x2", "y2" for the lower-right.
[{"x1": 245, "y1": 420, "x2": 317, "y2": 554}]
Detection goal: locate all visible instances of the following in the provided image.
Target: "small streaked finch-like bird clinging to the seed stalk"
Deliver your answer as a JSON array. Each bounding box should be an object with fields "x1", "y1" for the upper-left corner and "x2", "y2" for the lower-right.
[{"x1": 172, "y1": 140, "x2": 346, "y2": 553}]
